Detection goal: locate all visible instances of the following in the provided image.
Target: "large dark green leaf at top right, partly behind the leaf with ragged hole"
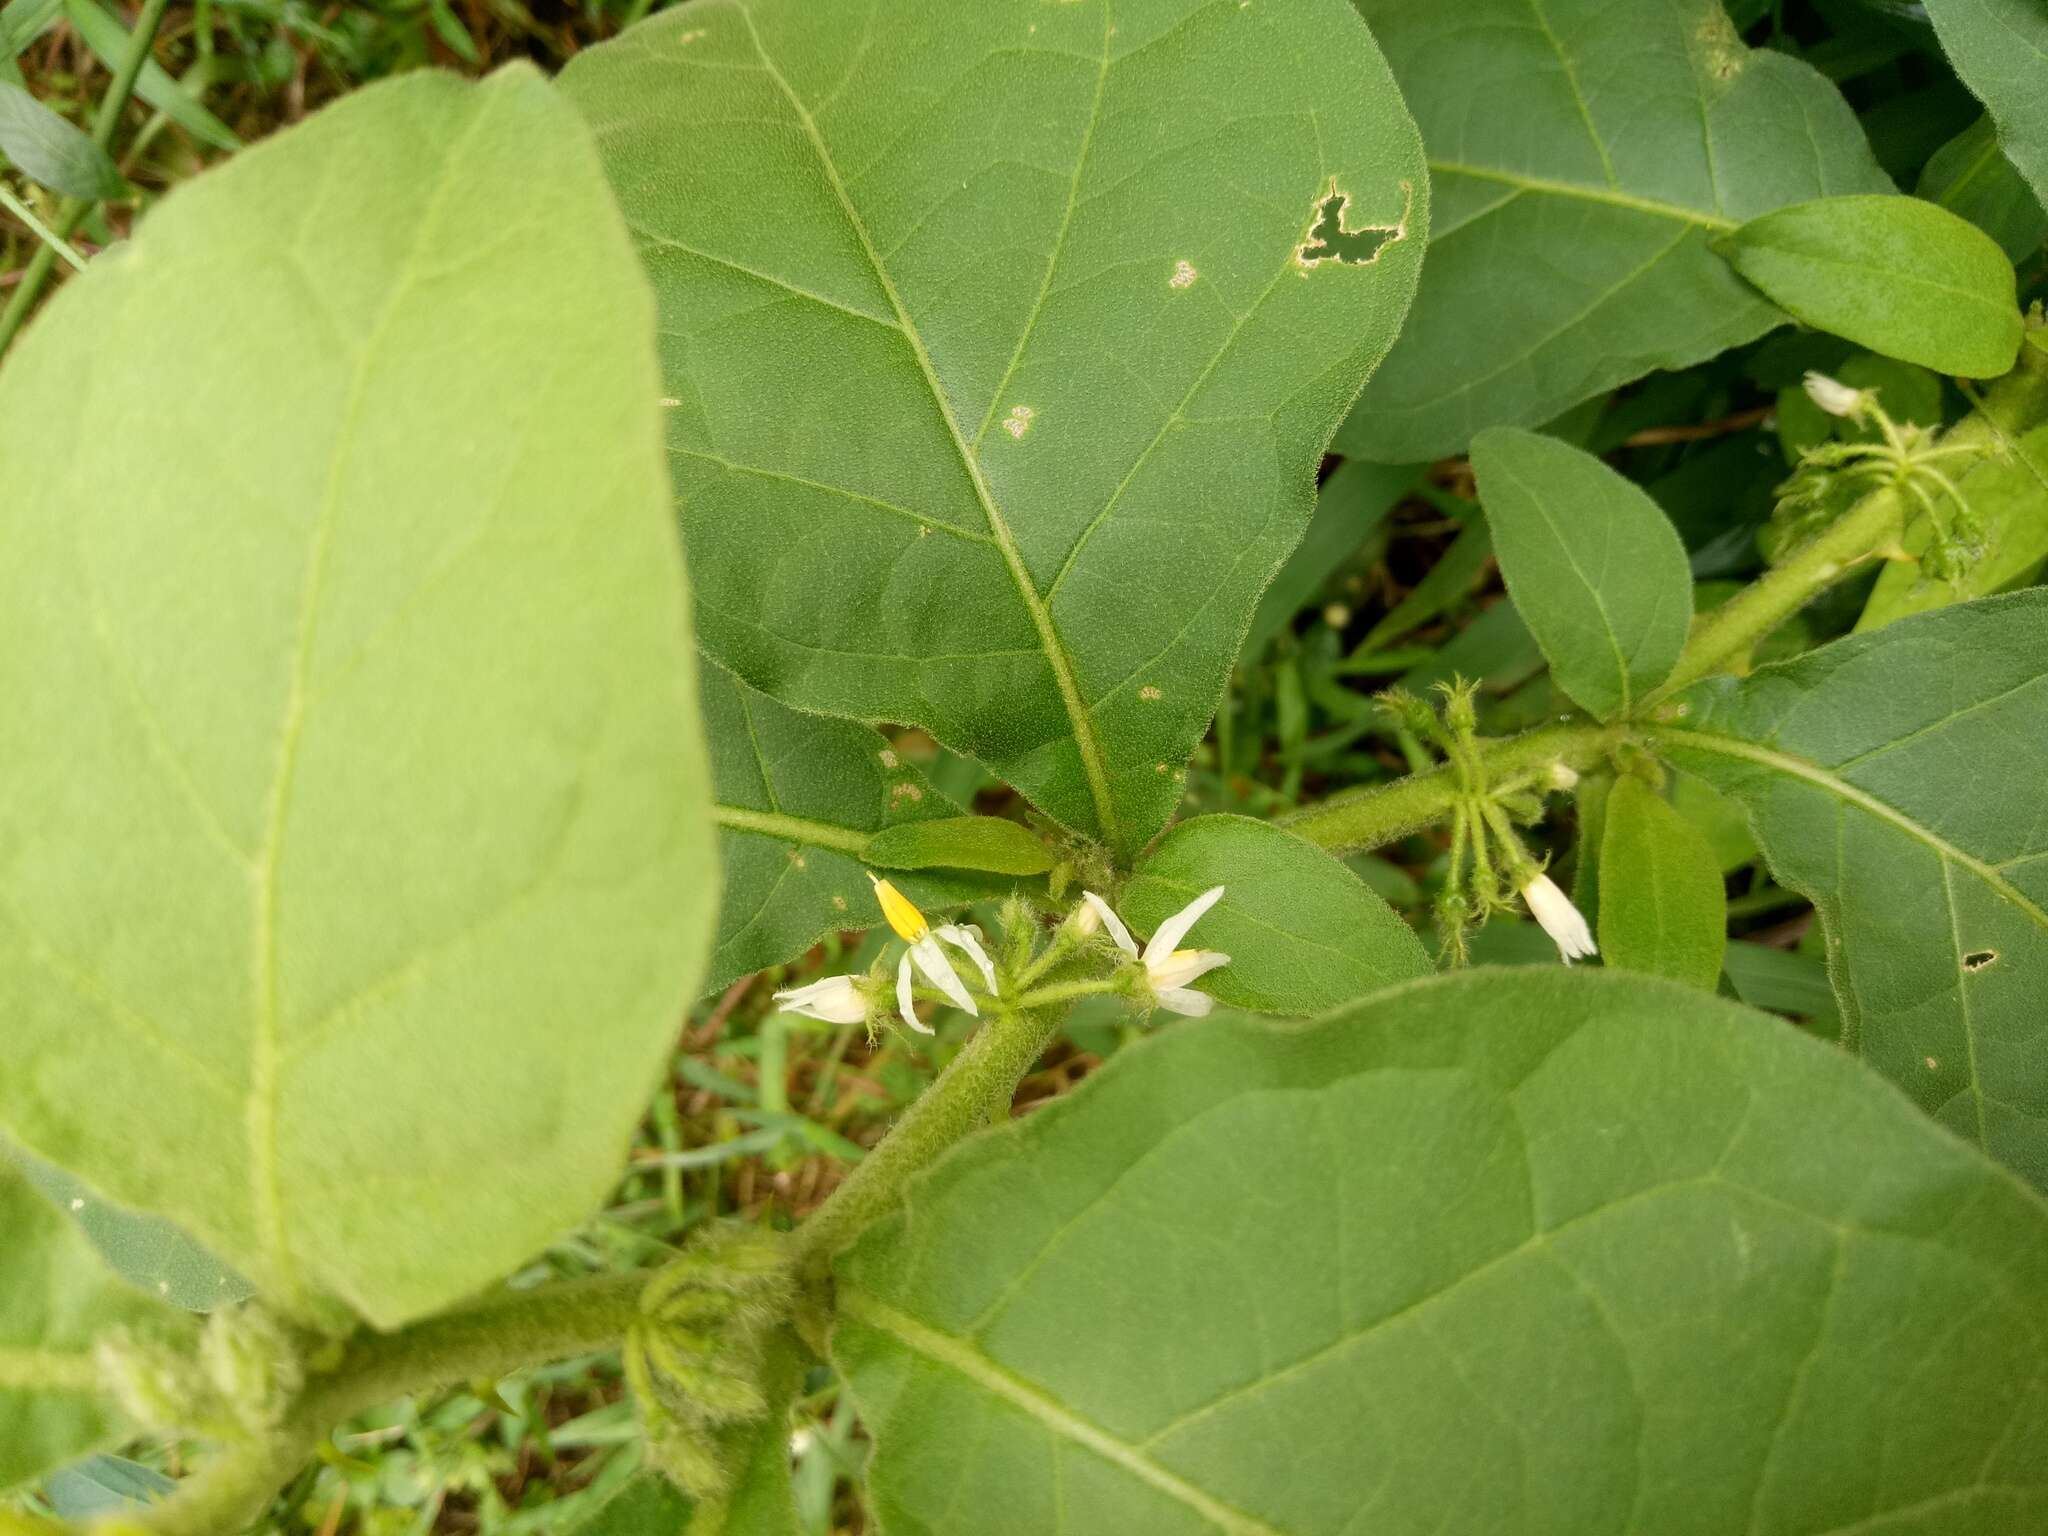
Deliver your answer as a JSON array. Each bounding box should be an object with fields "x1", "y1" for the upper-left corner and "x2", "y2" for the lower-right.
[{"x1": 1339, "y1": 0, "x2": 1890, "y2": 463}]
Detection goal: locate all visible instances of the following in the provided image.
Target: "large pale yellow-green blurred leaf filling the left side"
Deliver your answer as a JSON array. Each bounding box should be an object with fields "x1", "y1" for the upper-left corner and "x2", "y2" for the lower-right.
[{"x1": 0, "y1": 68, "x2": 717, "y2": 1327}]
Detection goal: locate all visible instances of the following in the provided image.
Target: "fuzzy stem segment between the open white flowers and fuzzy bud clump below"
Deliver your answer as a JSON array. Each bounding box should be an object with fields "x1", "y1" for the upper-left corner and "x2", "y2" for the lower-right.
[{"x1": 791, "y1": 1006, "x2": 1059, "y2": 1278}]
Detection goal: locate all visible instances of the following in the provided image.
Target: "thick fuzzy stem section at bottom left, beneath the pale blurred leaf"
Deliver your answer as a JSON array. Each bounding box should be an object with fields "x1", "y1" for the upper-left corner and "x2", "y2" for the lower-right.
[{"x1": 123, "y1": 1274, "x2": 647, "y2": 1536}]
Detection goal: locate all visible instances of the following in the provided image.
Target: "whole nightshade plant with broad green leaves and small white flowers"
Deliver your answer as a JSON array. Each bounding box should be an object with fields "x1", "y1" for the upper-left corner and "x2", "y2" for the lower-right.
[{"x1": 0, "y1": 0, "x2": 2048, "y2": 1536}]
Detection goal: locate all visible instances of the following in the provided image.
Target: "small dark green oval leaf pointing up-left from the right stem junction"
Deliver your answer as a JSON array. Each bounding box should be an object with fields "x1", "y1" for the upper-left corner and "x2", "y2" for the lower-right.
[{"x1": 1473, "y1": 428, "x2": 1692, "y2": 719}]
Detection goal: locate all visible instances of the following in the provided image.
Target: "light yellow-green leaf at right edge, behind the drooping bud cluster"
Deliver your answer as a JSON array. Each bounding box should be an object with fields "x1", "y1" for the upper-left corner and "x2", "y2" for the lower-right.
[{"x1": 1855, "y1": 426, "x2": 2048, "y2": 631}]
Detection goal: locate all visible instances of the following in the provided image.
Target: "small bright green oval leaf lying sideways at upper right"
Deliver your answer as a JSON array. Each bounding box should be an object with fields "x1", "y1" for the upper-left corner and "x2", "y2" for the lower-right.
[{"x1": 1722, "y1": 197, "x2": 2025, "y2": 379}]
